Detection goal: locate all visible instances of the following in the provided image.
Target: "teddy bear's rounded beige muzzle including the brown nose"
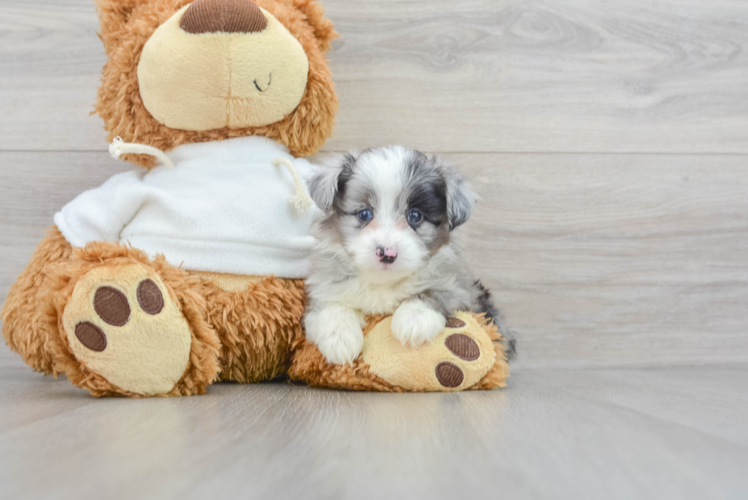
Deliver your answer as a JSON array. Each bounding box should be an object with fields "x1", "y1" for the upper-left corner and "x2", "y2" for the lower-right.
[{"x1": 137, "y1": 0, "x2": 309, "y2": 132}]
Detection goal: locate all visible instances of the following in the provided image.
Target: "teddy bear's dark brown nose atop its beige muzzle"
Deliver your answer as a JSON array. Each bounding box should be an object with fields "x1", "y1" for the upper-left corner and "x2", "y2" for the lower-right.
[{"x1": 179, "y1": 0, "x2": 268, "y2": 35}]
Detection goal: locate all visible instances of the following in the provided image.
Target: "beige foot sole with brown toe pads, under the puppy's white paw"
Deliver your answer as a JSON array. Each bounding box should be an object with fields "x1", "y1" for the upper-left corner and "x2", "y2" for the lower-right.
[{"x1": 361, "y1": 312, "x2": 496, "y2": 391}]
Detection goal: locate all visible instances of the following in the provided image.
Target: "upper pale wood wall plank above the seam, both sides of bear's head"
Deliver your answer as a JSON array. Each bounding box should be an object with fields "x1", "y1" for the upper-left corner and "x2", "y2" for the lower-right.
[{"x1": 0, "y1": 0, "x2": 748, "y2": 153}]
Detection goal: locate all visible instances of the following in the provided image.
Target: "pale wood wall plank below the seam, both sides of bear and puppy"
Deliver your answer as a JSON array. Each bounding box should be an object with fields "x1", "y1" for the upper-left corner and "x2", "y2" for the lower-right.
[{"x1": 0, "y1": 148, "x2": 748, "y2": 368}]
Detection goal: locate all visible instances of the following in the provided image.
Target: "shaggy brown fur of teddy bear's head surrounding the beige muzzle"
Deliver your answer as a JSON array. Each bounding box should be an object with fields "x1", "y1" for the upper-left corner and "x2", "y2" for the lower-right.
[{"x1": 96, "y1": 0, "x2": 338, "y2": 168}]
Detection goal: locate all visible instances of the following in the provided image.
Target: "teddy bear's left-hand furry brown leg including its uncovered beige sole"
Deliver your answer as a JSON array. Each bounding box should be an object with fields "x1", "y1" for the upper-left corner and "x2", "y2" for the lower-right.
[{"x1": 56, "y1": 243, "x2": 220, "y2": 397}]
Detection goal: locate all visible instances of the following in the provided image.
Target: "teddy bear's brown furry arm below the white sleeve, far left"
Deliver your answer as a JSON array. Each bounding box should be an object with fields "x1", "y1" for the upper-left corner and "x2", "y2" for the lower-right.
[{"x1": 2, "y1": 226, "x2": 73, "y2": 377}]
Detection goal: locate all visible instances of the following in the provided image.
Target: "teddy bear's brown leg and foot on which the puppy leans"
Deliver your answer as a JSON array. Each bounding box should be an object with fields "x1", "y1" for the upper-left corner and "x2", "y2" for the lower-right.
[{"x1": 290, "y1": 312, "x2": 509, "y2": 392}]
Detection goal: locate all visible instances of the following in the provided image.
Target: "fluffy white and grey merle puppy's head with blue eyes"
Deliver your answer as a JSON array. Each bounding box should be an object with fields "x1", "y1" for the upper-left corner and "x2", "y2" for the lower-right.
[{"x1": 309, "y1": 146, "x2": 476, "y2": 279}]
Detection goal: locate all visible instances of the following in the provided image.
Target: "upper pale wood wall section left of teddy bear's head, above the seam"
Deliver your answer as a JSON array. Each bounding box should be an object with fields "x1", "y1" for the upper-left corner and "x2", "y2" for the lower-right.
[{"x1": 0, "y1": 0, "x2": 106, "y2": 150}]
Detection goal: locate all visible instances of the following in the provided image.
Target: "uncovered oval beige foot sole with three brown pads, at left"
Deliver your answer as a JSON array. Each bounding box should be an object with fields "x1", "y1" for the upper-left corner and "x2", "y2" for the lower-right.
[{"x1": 63, "y1": 264, "x2": 192, "y2": 396}]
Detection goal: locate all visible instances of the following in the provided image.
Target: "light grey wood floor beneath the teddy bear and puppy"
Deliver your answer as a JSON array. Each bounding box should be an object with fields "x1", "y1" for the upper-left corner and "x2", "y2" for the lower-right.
[{"x1": 0, "y1": 367, "x2": 748, "y2": 500}]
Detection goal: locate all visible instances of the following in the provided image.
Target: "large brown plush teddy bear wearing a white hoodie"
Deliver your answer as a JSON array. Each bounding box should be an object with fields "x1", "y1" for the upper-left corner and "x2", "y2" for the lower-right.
[{"x1": 2, "y1": 0, "x2": 509, "y2": 397}]
